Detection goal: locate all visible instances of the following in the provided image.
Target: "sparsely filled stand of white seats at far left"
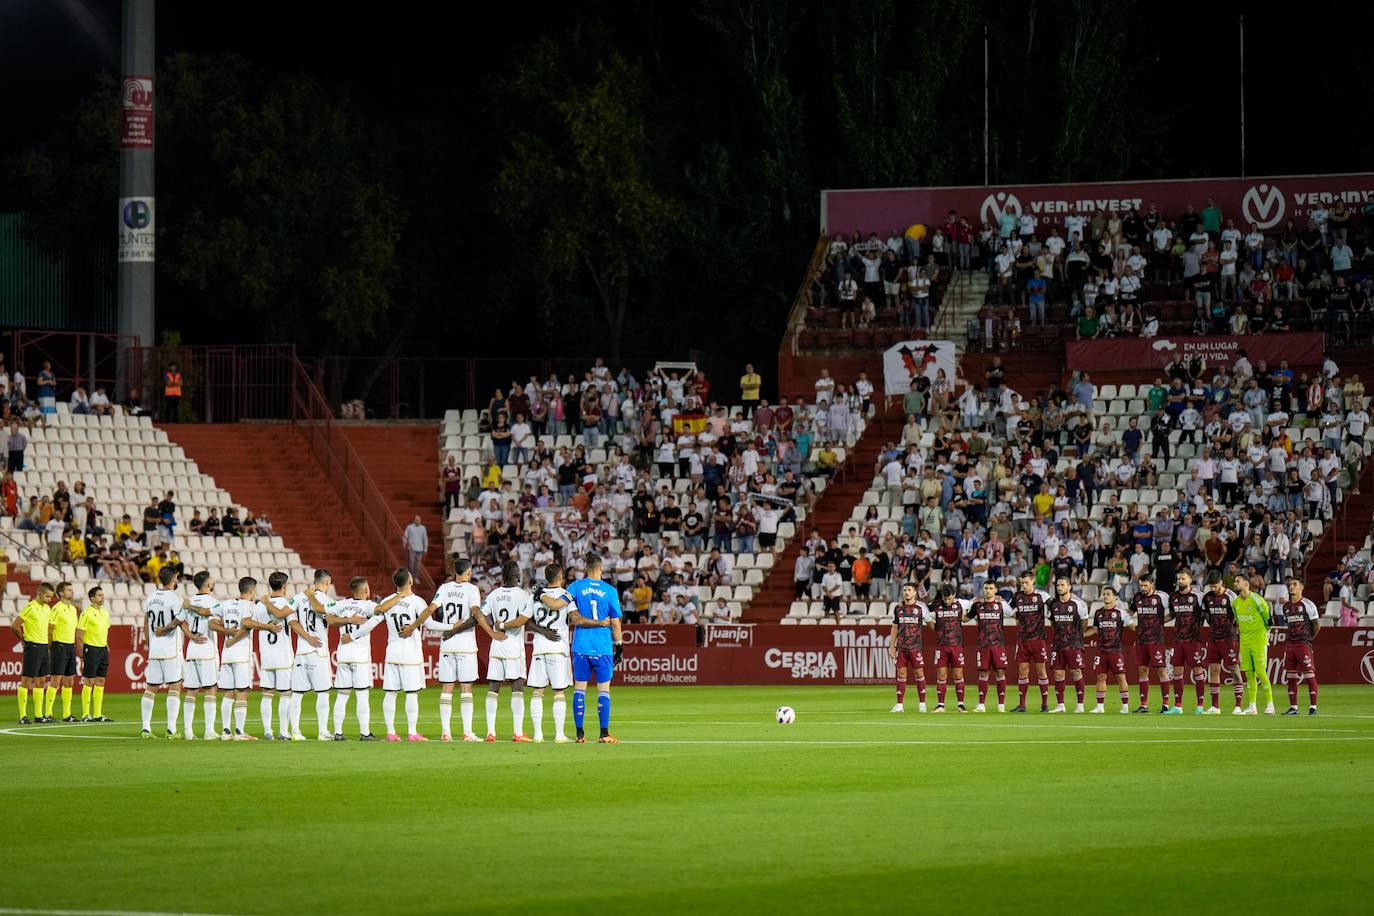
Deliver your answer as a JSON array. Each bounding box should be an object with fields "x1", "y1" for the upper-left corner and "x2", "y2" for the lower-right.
[{"x1": 0, "y1": 401, "x2": 308, "y2": 623}]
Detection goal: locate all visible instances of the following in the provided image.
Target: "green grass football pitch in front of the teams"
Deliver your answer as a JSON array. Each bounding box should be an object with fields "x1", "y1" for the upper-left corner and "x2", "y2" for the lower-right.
[{"x1": 0, "y1": 687, "x2": 1374, "y2": 916}]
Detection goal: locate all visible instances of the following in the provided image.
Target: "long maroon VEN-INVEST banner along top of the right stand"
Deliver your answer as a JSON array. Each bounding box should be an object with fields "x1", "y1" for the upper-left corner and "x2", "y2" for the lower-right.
[{"x1": 820, "y1": 172, "x2": 1374, "y2": 236}]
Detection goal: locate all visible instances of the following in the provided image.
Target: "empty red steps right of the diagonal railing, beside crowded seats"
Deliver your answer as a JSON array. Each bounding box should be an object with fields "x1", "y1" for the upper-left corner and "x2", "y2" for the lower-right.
[{"x1": 341, "y1": 423, "x2": 444, "y2": 582}]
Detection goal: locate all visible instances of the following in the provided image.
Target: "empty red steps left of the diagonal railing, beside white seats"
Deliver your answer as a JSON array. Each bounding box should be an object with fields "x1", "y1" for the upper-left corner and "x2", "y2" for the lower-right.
[{"x1": 162, "y1": 423, "x2": 387, "y2": 593}]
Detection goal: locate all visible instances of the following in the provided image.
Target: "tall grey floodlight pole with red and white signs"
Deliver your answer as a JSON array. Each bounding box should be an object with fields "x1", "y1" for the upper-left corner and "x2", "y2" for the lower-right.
[{"x1": 115, "y1": 0, "x2": 157, "y2": 401}]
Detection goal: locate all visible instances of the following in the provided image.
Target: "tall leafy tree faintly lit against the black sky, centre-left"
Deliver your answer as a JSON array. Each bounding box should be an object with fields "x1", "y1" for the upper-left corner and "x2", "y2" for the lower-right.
[{"x1": 496, "y1": 26, "x2": 683, "y2": 364}]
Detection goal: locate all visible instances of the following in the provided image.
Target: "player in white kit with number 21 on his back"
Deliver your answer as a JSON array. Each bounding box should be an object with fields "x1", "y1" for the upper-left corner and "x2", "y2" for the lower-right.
[{"x1": 425, "y1": 558, "x2": 495, "y2": 742}]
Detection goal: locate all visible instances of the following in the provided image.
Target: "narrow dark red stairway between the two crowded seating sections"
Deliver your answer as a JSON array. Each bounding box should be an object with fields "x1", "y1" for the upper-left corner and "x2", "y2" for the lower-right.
[{"x1": 743, "y1": 401, "x2": 903, "y2": 623}]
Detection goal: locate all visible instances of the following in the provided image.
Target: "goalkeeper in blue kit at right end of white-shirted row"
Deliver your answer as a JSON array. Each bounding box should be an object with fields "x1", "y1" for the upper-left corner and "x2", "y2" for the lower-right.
[{"x1": 567, "y1": 553, "x2": 622, "y2": 744}]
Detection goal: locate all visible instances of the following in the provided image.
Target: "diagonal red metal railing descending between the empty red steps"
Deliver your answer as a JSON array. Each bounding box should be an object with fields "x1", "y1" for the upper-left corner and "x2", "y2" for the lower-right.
[{"x1": 291, "y1": 360, "x2": 437, "y2": 592}]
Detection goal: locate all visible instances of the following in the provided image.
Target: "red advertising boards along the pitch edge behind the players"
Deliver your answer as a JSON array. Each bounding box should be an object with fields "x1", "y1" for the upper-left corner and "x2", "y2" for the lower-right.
[{"x1": 0, "y1": 625, "x2": 1374, "y2": 692}]
